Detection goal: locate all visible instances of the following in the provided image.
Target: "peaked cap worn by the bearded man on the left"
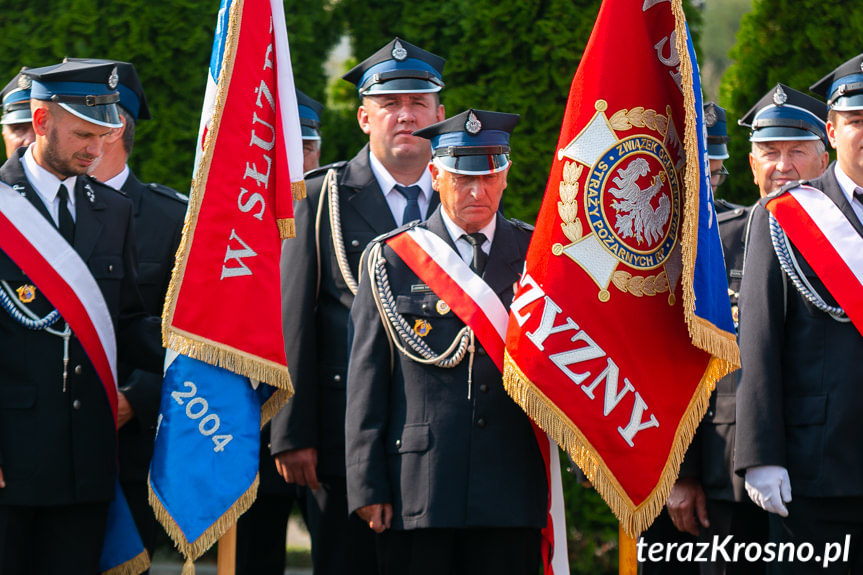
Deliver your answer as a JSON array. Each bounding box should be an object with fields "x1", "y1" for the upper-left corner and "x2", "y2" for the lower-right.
[{"x1": 22, "y1": 60, "x2": 123, "y2": 128}]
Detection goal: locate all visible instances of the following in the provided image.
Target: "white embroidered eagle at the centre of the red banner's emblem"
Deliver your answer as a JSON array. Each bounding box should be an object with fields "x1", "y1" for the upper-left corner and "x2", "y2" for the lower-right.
[{"x1": 608, "y1": 158, "x2": 671, "y2": 244}]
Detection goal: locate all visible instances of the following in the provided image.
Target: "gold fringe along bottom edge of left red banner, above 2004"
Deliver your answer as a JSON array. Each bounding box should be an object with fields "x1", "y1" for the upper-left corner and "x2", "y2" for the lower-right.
[{"x1": 162, "y1": 327, "x2": 294, "y2": 395}]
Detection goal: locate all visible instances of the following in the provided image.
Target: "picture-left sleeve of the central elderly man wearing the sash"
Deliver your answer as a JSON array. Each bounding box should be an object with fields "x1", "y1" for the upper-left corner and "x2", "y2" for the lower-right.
[{"x1": 345, "y1": 245, "x2": 392, "y2": 513}]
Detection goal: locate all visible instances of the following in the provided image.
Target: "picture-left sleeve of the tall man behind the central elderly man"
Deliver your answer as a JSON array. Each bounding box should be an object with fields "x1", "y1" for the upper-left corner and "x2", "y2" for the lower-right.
[{"x1": 270, "y1": 182, "x2": 320, "y2": 455}]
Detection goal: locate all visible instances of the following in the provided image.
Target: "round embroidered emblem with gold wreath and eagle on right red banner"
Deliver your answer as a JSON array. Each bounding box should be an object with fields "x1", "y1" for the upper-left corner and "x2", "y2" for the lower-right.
[{"x1": 552, "y1": 100, "x2": 684, "y2": 305}]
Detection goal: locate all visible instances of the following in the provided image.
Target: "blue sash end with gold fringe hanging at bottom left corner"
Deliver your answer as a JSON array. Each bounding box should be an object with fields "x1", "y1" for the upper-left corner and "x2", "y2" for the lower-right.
[{"x1": 99, "y1": 477, "x2": 150, "y2": 575}]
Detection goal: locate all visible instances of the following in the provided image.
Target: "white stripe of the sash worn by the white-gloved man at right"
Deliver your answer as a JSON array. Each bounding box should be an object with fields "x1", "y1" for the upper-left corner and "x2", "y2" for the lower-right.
[{"x1": 789, "y1": 186, "x2": 863, "y2": 283}]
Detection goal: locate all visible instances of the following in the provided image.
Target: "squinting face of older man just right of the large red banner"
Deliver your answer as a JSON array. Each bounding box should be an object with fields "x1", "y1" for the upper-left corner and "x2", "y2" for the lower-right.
[{"x1": 749, "y1": 140, "x2": 829, "y2": 198}]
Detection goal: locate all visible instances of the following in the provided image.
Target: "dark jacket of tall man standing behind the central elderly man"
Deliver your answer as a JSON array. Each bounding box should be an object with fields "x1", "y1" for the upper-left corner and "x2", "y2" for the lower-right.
[{"x1": 270, "y1": 145, "x2": 438, "y2": 477}]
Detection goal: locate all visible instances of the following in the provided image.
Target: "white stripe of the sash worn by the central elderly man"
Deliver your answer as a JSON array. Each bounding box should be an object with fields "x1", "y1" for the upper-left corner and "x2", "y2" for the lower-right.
[{"x1": 406, "y1": 227, "x2": 509, "y2": 341}]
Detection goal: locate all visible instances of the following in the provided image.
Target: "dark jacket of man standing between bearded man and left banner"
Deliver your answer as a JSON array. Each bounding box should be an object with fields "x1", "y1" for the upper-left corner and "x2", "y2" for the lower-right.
[{"x1": 118, "y1": 171, "x2": 189, "y2": 481}]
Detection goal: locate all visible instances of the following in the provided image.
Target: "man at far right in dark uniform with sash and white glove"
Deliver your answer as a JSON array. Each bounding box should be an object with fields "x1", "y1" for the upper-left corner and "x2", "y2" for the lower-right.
[{"x1": 735, "y1": 54, "x2": 863, "y2": 574}]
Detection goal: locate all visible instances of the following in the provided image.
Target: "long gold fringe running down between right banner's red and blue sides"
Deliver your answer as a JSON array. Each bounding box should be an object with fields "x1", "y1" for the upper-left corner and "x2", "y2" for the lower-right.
[{"x1": 671, "y1": 0, "x2": 740, "y2": 377}]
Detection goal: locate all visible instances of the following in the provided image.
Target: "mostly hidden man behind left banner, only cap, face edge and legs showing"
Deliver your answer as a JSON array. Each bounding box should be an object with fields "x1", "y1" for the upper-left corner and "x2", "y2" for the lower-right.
[{"x1": 237, "y1": 86, "x2": 324, "y2": 575}]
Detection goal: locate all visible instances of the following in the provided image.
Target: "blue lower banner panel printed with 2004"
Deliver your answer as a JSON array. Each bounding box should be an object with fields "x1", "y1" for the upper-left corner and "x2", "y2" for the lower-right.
[{"x1": 150, "y1": 352, "x2": 267, "y2": 559}]
